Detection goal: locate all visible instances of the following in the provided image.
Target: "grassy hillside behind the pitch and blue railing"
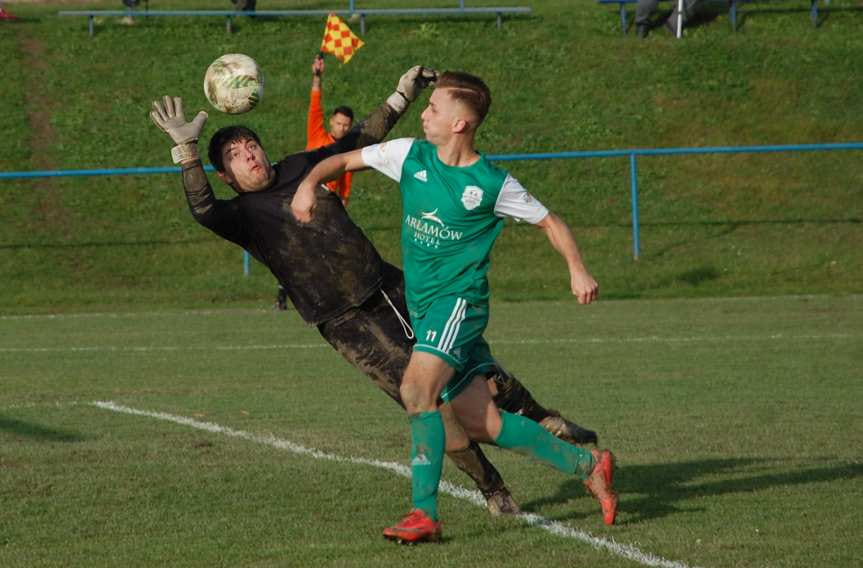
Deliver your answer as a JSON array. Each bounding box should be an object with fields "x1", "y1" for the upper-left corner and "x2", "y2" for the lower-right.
[{"x1": 0, "y1": 0, "x2": 863, "y2": 313}]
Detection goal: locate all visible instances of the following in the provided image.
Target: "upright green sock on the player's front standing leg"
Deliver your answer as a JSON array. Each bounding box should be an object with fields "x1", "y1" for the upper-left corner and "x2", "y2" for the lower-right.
[{"x1": 409, "y1": 410, "x2": 446, "y2": 521}]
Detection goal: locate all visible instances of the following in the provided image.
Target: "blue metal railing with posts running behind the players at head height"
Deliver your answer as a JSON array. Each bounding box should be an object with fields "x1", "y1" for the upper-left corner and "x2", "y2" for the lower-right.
[{"x1": 0, "y1": 142, "x2": 863, "y2": 268}]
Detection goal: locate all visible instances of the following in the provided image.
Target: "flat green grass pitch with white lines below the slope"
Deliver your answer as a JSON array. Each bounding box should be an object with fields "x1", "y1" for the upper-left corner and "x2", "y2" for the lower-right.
[{"x1": 0, "y1": 295, "x2": 863, "y2": 567}]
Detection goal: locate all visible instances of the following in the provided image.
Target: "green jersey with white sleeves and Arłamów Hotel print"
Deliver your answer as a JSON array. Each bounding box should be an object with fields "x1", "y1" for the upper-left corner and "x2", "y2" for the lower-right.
[{"x1": 363, "y1": 138, "x2": 548, "y2": 317}]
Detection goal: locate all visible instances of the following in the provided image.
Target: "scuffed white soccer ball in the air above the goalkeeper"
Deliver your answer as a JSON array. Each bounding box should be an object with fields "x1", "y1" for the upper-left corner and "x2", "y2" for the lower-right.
[{"x1": 204, "y1": 53, "x2": 264, "y2": 114}]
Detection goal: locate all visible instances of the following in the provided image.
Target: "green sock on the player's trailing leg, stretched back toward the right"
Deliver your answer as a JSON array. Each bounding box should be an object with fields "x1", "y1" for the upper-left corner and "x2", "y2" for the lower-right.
[{"x1": 494, "y1": 412, "x2": 594, "y2": 479}]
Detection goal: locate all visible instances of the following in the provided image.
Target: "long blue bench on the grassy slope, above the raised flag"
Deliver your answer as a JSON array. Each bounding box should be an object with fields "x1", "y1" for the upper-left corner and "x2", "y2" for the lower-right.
[{"x1": 57, "y1": 4, "x2": 531, "y2": 36}]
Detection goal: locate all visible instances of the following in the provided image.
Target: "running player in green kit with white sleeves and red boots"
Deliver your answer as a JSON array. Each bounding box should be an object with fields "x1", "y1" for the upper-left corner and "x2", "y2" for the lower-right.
[{"x1": 291, "y1": 72, "x2": 617, "y2": 542}]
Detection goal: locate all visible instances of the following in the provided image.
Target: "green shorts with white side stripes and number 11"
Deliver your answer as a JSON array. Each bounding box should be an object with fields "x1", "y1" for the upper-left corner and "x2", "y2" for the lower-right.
[{"x1": 411, "y1": 296, "x2": 495, "y2": 402}]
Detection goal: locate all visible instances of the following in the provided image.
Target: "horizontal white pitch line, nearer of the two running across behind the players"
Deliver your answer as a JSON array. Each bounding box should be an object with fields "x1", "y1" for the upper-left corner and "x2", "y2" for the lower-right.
[{"x1": 0, "y1": 333, "x2": 863, "y2": 353}]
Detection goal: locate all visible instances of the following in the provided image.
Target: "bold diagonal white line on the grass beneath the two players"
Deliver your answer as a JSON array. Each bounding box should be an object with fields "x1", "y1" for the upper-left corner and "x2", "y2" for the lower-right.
[{"x1": 92, "y1": 401, "x2": 700, "y2": 568}]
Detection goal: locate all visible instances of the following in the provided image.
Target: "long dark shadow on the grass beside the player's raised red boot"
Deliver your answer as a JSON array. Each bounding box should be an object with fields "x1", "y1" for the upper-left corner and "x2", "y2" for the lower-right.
[{"x1": 522, "y1": 458, "x2": 863, "y2": 524}]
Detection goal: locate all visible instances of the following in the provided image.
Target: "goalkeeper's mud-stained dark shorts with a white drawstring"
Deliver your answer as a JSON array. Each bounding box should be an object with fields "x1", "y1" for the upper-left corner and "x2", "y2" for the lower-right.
[{"x1": 318, "y1": 263, "x2": 413, "y2": 407}]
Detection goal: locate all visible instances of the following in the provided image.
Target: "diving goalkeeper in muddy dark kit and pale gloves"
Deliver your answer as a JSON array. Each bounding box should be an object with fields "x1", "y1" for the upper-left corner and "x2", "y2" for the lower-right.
[{"x1": 150, "y1": 66, "x2": 597, "y2": 514}]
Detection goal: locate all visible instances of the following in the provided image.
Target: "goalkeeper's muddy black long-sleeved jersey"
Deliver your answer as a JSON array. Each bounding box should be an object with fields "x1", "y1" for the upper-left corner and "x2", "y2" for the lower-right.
[{"x1": 183, "y1": 101, "x2": 398, "y2": 324}]
